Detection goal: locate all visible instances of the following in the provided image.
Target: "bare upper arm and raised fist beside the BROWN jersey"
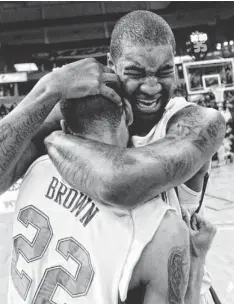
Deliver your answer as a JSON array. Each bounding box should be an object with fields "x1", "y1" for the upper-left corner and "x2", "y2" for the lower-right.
[{"x1": 126, "y1": 210, "x2": 216, "y2": 304}]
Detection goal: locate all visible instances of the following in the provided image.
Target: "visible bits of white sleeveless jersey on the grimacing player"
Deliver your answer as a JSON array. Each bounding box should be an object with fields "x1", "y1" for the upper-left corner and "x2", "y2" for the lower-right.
[{"x1": 132, "y1": 97, "x2": 211, "y2": 303}]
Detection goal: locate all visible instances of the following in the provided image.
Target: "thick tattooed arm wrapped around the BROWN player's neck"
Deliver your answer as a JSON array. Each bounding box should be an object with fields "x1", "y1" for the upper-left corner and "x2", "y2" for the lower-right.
[{"x1": 46, "y1": 107, "x2": 225, "y2": 207}]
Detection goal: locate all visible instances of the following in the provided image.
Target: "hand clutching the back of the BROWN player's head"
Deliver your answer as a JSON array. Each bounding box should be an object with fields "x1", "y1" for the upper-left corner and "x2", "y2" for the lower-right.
[{"x1": 45, "y1": 58, "x2": 122, "y2": 105}]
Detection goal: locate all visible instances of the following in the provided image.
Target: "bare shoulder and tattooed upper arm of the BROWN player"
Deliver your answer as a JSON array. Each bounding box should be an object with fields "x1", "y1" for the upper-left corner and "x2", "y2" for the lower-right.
[{"x1": 126, "y1": 211, "x2": 189, "y2": 304}]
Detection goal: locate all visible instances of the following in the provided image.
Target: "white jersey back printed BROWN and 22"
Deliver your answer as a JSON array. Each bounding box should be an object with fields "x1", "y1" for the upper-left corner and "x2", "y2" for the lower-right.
[{"x1": 8, "y1": 156, "x2": 133, "y2": 304}]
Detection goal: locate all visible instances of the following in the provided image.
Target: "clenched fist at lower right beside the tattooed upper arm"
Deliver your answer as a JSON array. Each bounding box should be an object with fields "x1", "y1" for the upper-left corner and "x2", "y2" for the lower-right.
[{"x1": 182, "y1": 209, "x2": 217, "y2": 259}]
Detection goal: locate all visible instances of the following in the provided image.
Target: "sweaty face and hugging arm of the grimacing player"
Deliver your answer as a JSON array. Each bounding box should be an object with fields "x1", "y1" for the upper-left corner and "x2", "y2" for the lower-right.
[{"x1": 45, "y1": 42, "x2": 225, "y2": 207}]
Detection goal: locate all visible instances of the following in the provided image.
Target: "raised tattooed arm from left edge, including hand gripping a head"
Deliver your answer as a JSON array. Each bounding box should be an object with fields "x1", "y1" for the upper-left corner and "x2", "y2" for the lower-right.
[{"x1": 0, "y1": 58, "x2": 121, "y2": 193}]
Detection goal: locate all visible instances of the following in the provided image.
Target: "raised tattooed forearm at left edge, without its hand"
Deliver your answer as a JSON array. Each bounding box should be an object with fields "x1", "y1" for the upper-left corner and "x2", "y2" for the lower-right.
[{"x1": 0, "y1": 77, "x2": 58, "y2": 193}]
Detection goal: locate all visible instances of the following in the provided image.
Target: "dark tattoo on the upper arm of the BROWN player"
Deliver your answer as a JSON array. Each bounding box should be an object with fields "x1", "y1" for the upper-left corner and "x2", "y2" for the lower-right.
[{"x1": 168, "y1": 247, "x2": 189, "y2": 304}]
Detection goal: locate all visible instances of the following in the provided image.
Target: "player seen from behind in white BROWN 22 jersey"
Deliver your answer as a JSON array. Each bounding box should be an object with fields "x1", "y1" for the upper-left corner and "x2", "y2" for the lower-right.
[{"x1": 8, "y1": 96, "x2": 216, "y2": 304}]
